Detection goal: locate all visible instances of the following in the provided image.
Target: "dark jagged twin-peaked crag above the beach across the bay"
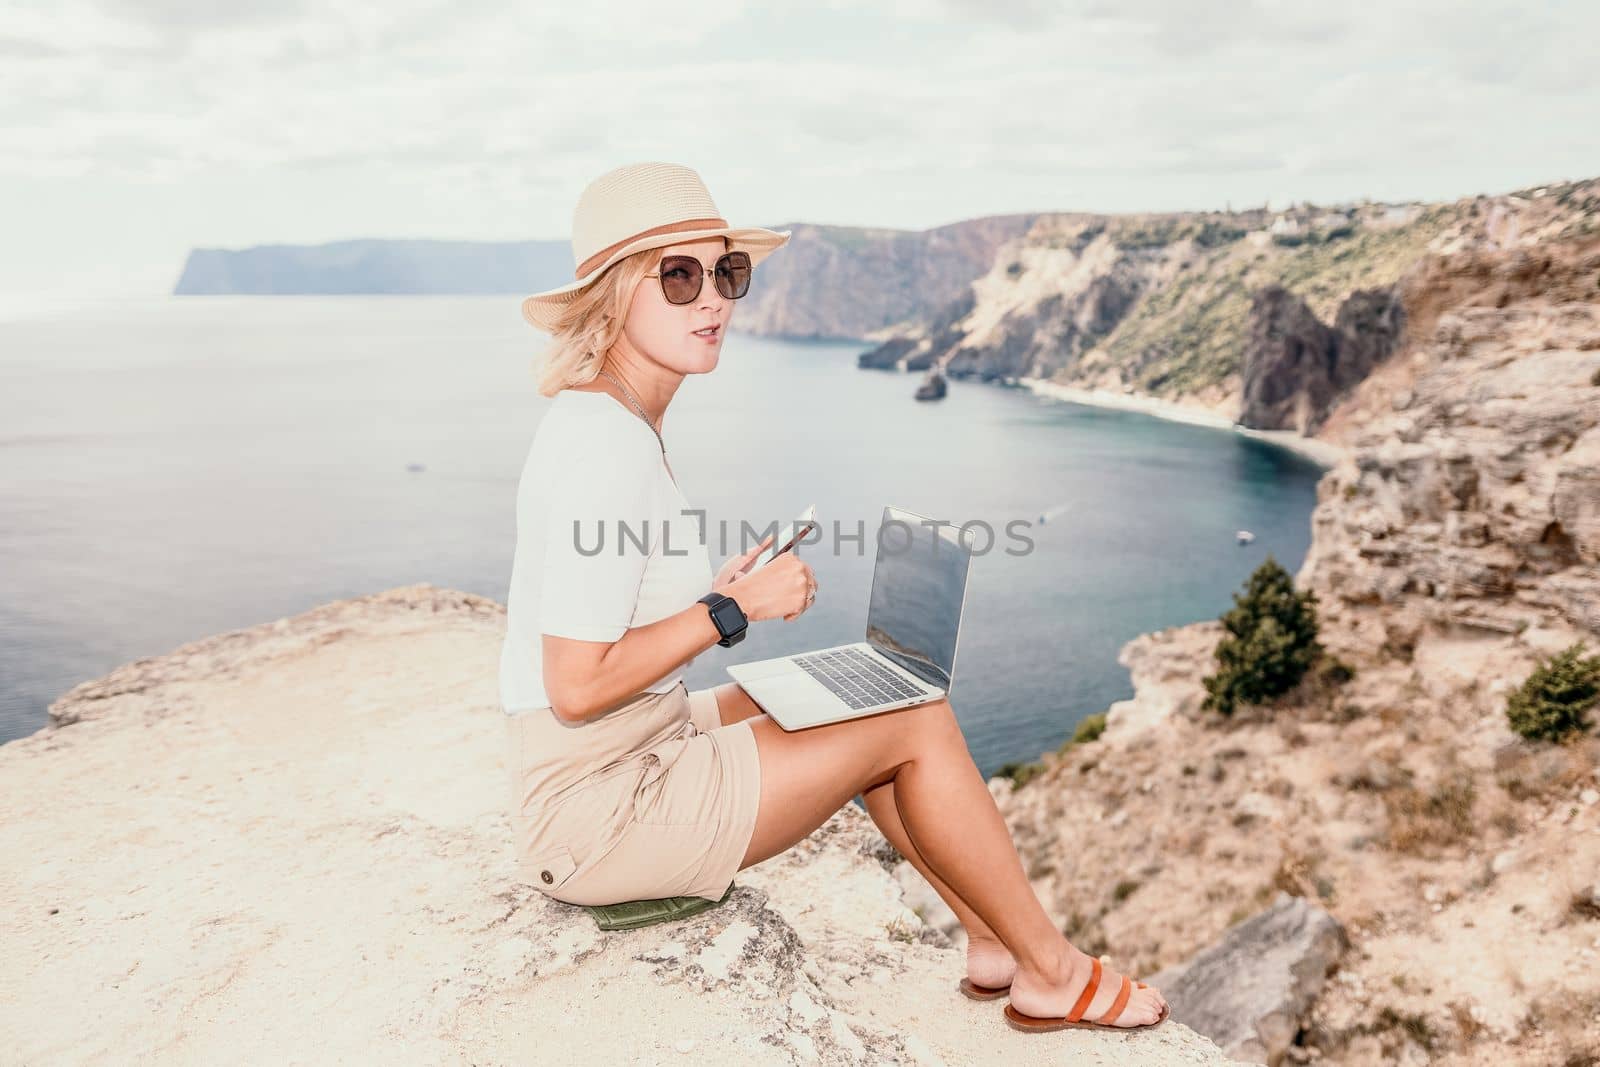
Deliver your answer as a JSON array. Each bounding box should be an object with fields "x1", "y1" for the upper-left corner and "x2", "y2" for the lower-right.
[{"x1": 1238, "y1": 285, "x2": 1405, "y2": 437}]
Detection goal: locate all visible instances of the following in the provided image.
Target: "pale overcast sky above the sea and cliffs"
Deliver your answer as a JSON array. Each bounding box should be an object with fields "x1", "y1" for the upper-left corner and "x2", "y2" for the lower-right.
[{"x1": 0, "y1": 0, "x2": 1600, "y2": 299}]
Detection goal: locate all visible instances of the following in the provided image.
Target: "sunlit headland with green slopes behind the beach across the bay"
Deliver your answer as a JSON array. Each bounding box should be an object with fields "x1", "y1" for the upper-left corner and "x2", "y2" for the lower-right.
[{"x1": 859, "y1": 179, "x2": 1600, "y2": 434}]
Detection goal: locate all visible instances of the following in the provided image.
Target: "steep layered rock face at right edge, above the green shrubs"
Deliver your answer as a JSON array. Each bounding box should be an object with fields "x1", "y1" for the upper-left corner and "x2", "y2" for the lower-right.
[{"x1": 1302, "y1": 242, "x2": 1600, "y2": 653}]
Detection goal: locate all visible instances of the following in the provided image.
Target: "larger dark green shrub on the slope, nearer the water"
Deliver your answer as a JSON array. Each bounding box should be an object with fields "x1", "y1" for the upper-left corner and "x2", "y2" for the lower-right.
[{"x1": 1202, "y1": 555, "x2": 1323, "y2": 715}]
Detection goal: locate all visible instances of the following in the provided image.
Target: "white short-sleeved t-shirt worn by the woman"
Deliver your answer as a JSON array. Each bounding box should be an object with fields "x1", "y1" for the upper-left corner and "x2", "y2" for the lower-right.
[{"x1": 499, "y1": 389, "x2": 714, "y2": 715}]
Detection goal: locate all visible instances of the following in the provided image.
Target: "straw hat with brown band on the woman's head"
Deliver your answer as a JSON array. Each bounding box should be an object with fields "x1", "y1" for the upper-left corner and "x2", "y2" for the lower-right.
[{"x1": 522, "y1": 163, "x2": 792, "y2": 333}]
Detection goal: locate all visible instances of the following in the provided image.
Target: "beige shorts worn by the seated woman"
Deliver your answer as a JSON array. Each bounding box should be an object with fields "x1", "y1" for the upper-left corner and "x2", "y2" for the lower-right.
[{"x1": 506, "y1": 681, "x2": 762, "y2": 904}]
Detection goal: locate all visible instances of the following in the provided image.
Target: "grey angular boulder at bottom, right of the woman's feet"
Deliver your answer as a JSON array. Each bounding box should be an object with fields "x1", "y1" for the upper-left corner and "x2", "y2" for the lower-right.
[{"x1": 1149, "y1": 891, "x2": 1349, "y2": 1067}]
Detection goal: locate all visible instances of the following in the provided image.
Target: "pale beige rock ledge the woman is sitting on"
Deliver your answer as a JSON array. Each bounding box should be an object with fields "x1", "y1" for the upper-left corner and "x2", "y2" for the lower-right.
[{"x1": 0, "y1": 585, "x2": 1230, "y2": 1067}]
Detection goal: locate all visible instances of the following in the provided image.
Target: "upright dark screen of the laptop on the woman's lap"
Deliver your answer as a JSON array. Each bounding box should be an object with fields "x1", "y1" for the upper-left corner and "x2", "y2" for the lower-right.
[{"x1": 867, "y1": 507, "x2": 973, "y2": 689}]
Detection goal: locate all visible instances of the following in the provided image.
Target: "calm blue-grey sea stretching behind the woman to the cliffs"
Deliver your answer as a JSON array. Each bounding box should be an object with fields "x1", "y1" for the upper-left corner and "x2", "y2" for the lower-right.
[{"x1": 0, "y1": 296, "x2": 1320, "y2": 773}]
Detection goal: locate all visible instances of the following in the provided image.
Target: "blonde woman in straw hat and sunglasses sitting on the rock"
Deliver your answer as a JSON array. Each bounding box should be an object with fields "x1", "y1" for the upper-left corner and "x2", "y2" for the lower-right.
[{"x1": 501, "y1": 163, "x2": 1166, "y2": 1030}]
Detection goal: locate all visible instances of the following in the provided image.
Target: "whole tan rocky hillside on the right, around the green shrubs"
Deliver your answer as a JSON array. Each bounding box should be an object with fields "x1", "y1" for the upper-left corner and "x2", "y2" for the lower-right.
[{"x1": 966, "y1": 227, "x2": 1600, "y2": 1065}]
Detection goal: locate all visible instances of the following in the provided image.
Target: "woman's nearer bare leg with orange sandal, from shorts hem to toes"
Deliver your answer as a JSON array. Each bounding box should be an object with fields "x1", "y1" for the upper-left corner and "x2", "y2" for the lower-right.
[{"x1": 739, "y1": 699, "x2": 1165, "y2": 1025}]
